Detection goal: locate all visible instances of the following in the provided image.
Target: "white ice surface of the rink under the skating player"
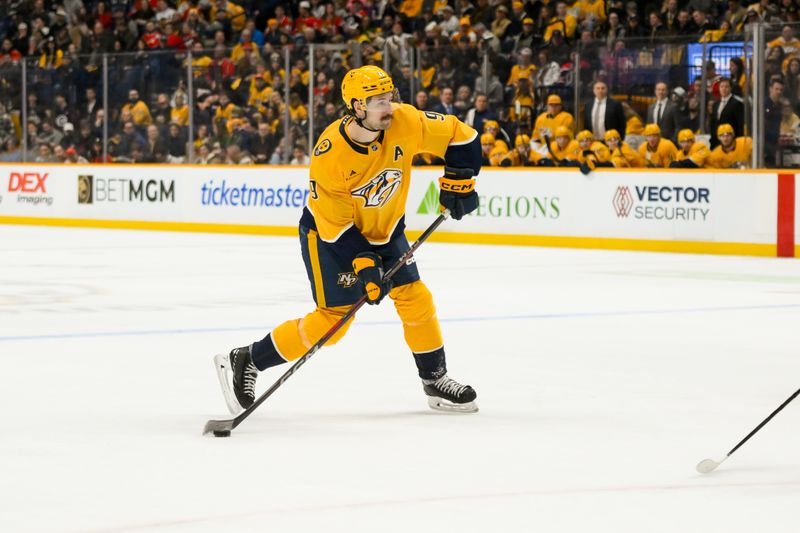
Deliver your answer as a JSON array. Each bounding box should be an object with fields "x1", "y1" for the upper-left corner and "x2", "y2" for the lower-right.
[{"x1": 0, "y1": 222, "x2": 800, "y2": 533}]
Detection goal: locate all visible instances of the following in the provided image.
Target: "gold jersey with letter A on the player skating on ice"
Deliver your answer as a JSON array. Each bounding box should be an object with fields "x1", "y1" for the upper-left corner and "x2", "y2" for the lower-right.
[{"x1": 308, "y1": 104, "x2": 478, "y2": 245}]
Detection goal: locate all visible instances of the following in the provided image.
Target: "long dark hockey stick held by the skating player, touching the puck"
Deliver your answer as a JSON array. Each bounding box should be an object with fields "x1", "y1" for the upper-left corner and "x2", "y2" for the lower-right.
[{"x1": 203, "y1": 209, "x2": 450, "y2": 437}]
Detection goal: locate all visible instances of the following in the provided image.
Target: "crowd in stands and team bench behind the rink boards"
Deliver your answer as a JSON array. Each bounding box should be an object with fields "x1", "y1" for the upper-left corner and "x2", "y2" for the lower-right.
[{"x1": 0, "y1": 0, "x2": 800, "y2": 168}]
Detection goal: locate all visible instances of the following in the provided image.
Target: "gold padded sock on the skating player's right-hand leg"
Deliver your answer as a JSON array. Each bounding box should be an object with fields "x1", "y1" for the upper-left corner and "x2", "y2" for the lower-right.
[{"x1": 389, "y1": 281, "x2": 443, "y2": 352}]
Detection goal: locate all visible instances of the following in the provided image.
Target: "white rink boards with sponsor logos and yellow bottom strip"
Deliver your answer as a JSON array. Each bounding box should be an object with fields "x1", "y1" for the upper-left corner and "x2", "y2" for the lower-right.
[{"x1": 0, "y1": 164, "x2": 800, "y2": 257}]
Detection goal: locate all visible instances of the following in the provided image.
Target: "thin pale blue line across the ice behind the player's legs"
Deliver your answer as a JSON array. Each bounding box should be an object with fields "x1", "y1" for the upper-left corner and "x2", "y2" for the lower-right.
[{"x1": 0, "y1": 304, "x2": 800, "y2": 342}]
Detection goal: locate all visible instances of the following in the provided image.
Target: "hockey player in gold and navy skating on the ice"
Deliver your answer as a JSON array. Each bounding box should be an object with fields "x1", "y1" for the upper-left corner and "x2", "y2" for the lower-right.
[{"x1": 215, "y1": 65, "x2": 481, "y2": 413}]
